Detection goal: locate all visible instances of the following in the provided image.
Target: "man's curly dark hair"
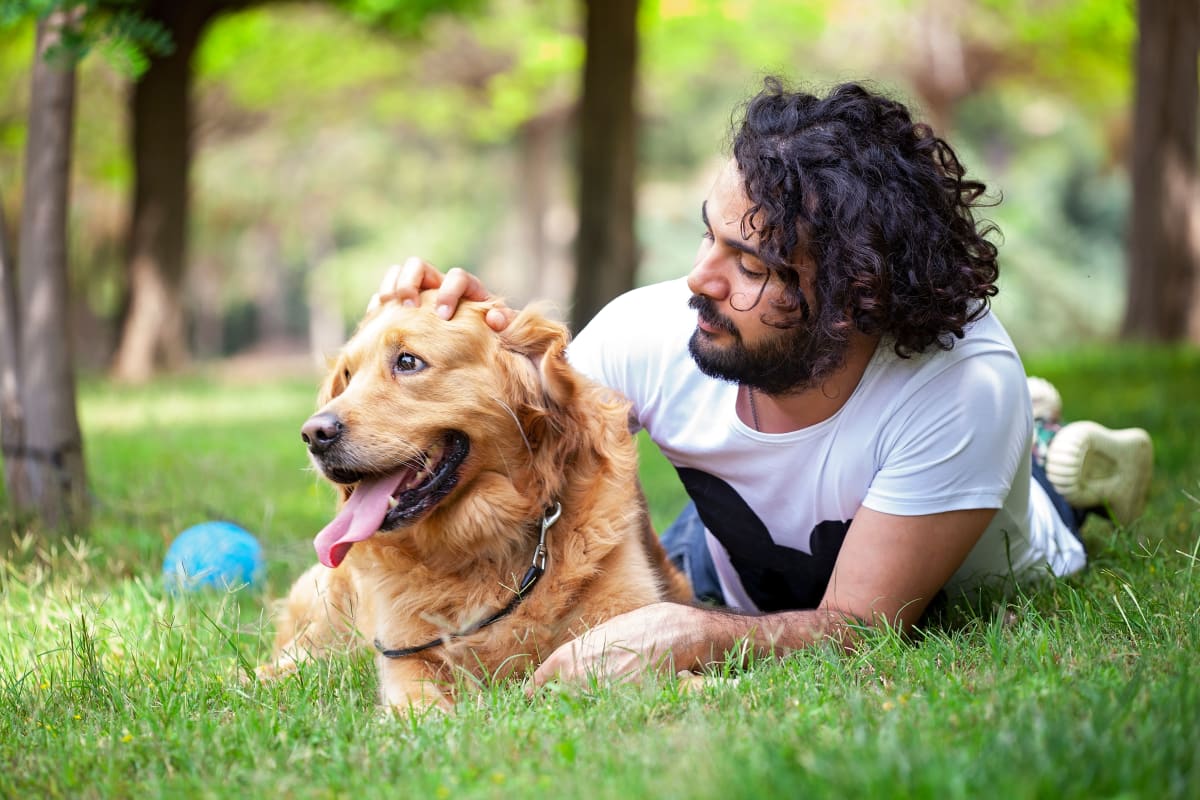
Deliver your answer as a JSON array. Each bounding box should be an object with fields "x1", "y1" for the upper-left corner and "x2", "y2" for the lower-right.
[{"x1": 732, "y1": 78, "x2": 998, "y2": 369}]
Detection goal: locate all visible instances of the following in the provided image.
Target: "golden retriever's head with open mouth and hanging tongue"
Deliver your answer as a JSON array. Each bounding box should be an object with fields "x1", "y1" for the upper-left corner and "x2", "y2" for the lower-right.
[{"x1": 301, "y1": 291, "x2": 614, "y2": 567}]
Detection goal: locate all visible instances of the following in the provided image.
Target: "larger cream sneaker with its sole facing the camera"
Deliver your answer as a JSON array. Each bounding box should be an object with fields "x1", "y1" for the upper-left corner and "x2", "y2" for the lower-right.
[{"x1": 1046, "y1": 422, "x2": 1154, "y2": 525}]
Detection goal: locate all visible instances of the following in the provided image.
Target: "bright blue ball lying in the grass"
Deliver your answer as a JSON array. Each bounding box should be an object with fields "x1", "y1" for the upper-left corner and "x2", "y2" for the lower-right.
[{"x1": 162, "y1": 522, "x2": 264, "y2": 591}]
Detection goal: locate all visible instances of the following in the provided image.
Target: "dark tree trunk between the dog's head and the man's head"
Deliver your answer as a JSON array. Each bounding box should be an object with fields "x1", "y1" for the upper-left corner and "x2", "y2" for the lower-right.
[{"x1": 571, "y1": 0, "x2": 637, "y2": 331}]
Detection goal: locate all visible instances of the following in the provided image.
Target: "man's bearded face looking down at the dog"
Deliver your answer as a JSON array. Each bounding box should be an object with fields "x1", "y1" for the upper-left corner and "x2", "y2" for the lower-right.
[{"x1": 688, "y1": 161, "x2": 844, "y2": 395}]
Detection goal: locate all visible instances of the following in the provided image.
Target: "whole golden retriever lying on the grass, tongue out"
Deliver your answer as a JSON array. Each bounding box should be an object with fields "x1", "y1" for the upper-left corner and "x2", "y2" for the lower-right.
[{"x1": 258, "y1": 293, "x2": 691, "y2": 709}]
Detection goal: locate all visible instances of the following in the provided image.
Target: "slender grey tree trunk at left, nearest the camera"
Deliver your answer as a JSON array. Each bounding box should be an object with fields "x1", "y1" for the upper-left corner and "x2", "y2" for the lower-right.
[{"x1": 12, "y1": 12, "x2": 88, "y2": 531}]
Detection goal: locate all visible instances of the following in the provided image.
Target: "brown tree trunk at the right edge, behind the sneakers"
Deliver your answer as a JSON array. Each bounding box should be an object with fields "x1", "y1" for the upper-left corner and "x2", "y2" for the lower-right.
[{"x1": 1122, "y1": 0, "x2": 1200, "y2": 342}]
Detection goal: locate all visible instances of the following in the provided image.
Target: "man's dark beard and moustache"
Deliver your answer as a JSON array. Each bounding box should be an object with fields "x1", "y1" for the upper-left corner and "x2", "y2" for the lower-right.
[{"x1": 688, "y1": 295, "x2": 846, "y2": 395}]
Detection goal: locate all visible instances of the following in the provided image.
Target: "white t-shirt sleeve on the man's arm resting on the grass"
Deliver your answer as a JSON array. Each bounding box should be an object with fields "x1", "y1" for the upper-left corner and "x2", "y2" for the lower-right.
[{"x1": 863, "y1": 350, "x2": 1033, "y2": 516}]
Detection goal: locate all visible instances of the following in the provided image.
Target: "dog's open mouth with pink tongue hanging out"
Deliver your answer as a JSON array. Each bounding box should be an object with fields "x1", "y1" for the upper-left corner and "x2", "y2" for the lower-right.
[{"x1": 313, "y1": 431, "x2": 470, "y2": 567}]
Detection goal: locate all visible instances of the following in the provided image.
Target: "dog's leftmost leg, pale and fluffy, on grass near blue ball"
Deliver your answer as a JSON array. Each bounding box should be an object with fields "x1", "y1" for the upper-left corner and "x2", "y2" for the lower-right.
[{"x1": 254, "y1": 564, "x2": 356, "y2": 680}]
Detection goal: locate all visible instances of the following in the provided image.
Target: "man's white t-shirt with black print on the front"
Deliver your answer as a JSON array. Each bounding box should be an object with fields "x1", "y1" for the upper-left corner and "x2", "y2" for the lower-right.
[{"x1": 569, "y1": 279, "x2": 1086, "y2": 612}]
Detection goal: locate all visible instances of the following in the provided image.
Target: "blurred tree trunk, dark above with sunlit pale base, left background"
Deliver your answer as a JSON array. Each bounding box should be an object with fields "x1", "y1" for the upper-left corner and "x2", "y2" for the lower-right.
[{"x1": 112, "y1": 0, "x2": 226, "y2": 381}]
